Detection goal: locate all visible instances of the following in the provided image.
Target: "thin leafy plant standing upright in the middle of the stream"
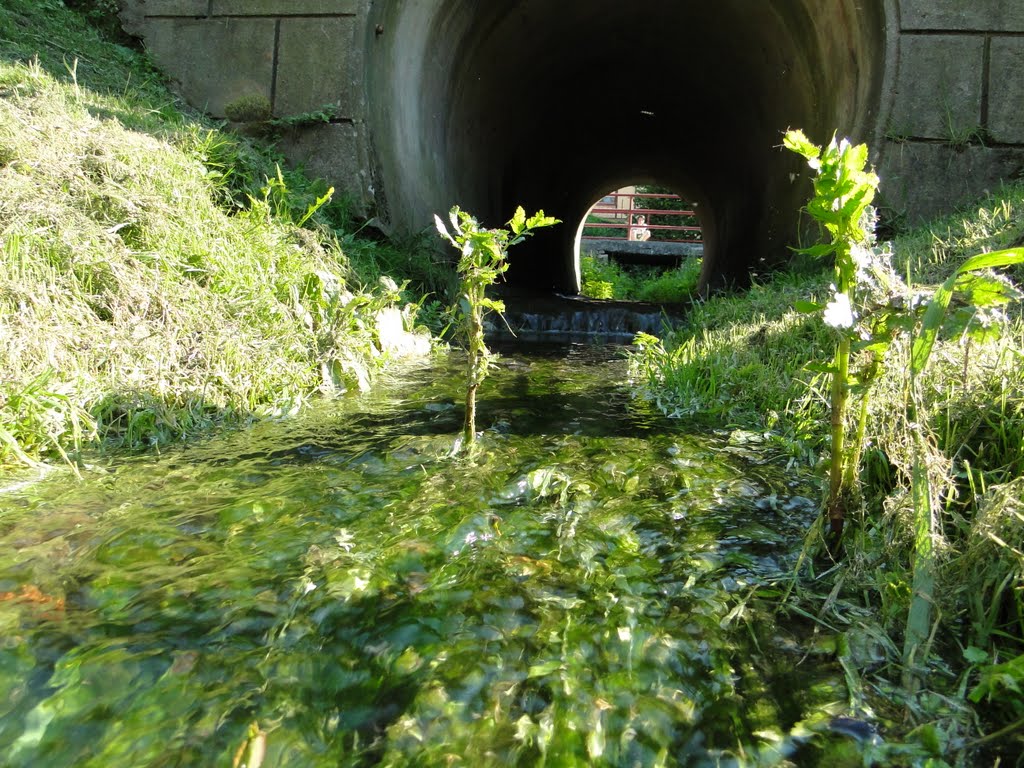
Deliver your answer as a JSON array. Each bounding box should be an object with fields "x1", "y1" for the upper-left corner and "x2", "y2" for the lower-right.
[{"x1": 434, "y1": 206, "x2": 560, "y2": 447}]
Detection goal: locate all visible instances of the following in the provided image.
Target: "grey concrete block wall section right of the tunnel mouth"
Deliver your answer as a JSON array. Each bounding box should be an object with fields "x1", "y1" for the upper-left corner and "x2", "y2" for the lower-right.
[{"x1": 879, "y1": 0, "x2": 1024, "y2": 222}]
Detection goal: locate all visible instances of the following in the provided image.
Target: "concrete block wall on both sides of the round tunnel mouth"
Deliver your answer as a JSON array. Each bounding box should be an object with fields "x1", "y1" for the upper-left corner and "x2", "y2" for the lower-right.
[{"x1": 122, "y1": 0, "x2": 1024, "y2": 233}]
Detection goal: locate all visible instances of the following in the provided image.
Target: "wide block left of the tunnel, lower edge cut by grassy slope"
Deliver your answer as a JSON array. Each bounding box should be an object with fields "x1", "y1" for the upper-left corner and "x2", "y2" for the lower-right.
[{"x1": 145, "y1": 18, "x2": 275, "y2": 117}]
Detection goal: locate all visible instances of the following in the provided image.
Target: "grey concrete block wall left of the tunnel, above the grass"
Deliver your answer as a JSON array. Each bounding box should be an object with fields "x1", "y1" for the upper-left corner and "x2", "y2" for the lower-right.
[{"x1": 122, "y1": 0, "x2": 372, "y2": 206}]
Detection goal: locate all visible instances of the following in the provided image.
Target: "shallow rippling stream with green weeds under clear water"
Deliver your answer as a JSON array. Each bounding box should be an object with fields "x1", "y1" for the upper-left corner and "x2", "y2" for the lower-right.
[{"x1": 0, "y1": 344, "x2": 864, "y2": 768}]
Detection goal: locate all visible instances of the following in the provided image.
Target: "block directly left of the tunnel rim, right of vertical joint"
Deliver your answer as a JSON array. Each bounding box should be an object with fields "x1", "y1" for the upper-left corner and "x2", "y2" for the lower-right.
[{"x1": 274, "y1": 17, "x2": 361, "y2": 118}]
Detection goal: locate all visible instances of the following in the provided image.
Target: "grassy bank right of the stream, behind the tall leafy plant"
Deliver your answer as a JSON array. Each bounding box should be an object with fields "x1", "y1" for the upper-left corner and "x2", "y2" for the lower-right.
[{"x1": 632, "y1": 184, "x2": 1024, "y2": 765}]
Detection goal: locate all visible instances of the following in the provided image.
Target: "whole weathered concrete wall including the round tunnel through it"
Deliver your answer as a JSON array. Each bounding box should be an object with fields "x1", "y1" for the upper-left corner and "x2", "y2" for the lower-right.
[{"x1": 116, "y1": 0, "x2": 1024, "y2": 290}]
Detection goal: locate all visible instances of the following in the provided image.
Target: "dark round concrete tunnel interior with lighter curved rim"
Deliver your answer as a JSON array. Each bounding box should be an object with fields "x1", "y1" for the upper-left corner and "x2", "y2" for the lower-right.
[{"x1": 366, "y1": 0, "x2": 890, "y2": 293}]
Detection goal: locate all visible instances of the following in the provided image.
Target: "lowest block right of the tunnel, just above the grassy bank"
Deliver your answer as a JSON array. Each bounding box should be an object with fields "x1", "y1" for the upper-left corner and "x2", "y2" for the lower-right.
[{"x1": 878, "y1": 141, "x2": 1024, "y2": 225}]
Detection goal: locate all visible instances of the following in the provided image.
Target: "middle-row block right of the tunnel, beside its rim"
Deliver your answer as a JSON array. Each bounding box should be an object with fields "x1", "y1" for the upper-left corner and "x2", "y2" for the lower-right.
[{"x1": 886, "y1": 35, "x2": 985, "y2": 142}]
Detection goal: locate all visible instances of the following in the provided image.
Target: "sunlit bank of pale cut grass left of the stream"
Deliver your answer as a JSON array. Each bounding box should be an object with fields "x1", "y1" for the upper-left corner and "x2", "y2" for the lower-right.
[{"x1": 0, "y1": 0, "x2": 440, "y2": 473}]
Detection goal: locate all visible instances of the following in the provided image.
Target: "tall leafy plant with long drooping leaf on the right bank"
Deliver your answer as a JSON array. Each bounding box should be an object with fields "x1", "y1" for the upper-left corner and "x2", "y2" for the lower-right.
[{"x1": 785, "y1": 131, "x2": 1024, "y2": 689}]
